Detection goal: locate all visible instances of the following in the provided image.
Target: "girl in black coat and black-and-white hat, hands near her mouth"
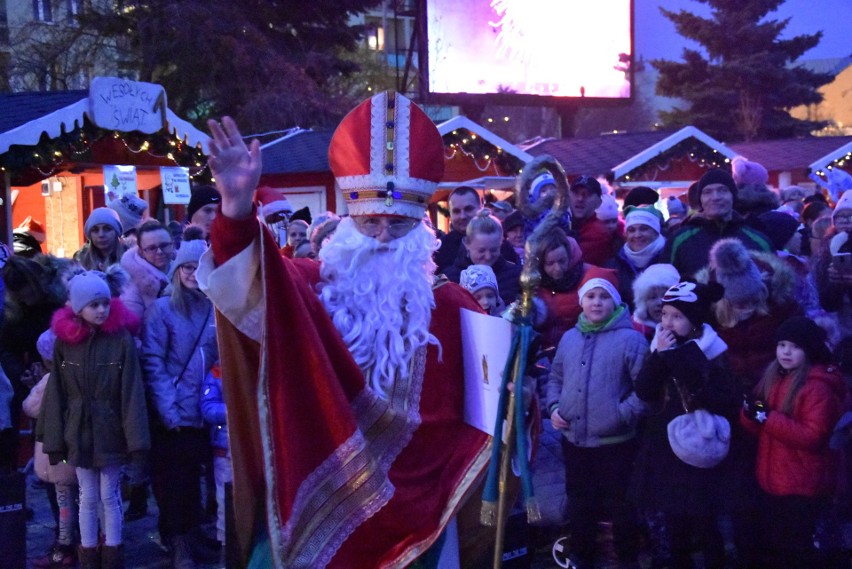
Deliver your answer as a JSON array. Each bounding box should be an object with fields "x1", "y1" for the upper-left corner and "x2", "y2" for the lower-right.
[{"x1": 632, "y1": 282, "x2": 740, "y2": 568}]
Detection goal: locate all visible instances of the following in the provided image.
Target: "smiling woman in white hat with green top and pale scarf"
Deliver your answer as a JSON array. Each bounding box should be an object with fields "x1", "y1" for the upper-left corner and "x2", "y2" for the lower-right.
[{"x1": 604, "y1": 205, "x2": 666, "y2": 310}]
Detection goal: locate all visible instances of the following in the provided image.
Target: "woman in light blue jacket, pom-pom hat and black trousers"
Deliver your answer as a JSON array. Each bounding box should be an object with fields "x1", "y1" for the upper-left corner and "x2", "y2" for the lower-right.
[{"x1": 141, "y1": 226, "x2": 218, "y2": 569}]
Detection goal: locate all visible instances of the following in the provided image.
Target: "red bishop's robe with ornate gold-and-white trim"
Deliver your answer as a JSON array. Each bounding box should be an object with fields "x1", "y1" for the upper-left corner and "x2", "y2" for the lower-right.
[{"x1": 199, "y1": 211, "x2": 490, "y2": 569}]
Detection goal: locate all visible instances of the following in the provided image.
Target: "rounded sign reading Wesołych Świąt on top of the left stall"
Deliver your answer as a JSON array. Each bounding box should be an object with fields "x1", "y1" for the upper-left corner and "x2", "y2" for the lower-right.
[{"x1": 89, "y1": 77, "x2": 167, "y2": 134}]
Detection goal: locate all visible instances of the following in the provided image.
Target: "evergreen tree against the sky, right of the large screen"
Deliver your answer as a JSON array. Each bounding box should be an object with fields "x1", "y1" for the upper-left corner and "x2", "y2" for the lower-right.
[{"x1": 653, "y1": 0, "x2": 833, "y2": 141}]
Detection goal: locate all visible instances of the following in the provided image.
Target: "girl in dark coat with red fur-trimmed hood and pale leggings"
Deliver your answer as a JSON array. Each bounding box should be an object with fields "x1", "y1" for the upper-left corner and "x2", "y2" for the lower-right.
[{"x1": 39, "y1": 271, "x2": 151, "y2": 569}]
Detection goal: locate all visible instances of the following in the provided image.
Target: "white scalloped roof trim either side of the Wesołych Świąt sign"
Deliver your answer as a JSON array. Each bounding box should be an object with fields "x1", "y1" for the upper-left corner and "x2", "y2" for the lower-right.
[{"x1": 0, "y1": 97, "x2": 211, "y2": 155}]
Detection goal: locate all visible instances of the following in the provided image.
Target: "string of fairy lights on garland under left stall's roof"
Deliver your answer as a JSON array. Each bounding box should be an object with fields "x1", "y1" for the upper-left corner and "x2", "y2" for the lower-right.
[{"x1": 0, "y1": 120, "x2": 212, "y2": 183}]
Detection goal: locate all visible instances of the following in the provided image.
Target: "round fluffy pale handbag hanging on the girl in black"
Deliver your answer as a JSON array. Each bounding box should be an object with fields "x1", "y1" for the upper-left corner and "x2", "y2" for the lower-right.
[{"x1": 667, "y1": 378, "x2": 731, "y2": 468}]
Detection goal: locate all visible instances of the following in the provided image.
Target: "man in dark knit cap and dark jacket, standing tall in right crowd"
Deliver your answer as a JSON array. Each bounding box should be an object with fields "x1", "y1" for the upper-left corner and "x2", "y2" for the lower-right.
[{"x1": 663, "y1": 169, "x2": 775, "y2": 278}]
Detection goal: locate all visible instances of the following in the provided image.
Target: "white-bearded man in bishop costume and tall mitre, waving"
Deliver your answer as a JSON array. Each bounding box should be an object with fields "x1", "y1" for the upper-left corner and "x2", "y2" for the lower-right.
[{"x1": 198, "y1": 93, "x2": 489, "y2": 569}]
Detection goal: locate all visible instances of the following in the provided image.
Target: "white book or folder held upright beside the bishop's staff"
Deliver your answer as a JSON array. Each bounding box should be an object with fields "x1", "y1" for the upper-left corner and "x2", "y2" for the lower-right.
[{"x1": 461, "y1": 308, "x2": 512, "y2": 435}]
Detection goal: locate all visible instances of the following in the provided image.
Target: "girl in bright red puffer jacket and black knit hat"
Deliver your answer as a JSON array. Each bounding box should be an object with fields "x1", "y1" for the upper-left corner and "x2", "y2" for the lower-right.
[{"x1": 740, "y1": 317, "x2": 846, "y2": 569}]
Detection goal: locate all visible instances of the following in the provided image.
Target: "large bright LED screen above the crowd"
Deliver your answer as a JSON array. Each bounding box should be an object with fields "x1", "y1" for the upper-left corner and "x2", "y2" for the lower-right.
[{"x1": 426, "y1": 0, "x2": 632, "y2": 99}]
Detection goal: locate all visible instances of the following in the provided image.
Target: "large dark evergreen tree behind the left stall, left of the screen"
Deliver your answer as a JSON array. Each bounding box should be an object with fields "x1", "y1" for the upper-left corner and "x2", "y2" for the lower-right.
[{"x1": 79, "y1": 0, "x2": 377, "y2": 133}]
